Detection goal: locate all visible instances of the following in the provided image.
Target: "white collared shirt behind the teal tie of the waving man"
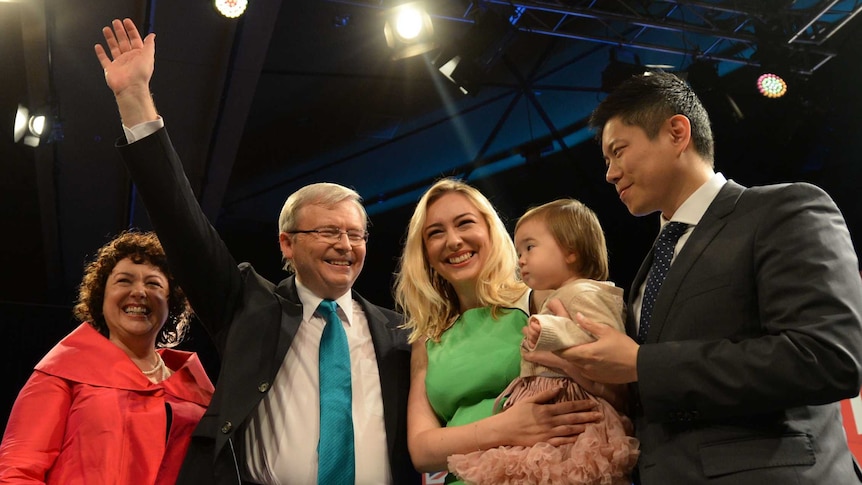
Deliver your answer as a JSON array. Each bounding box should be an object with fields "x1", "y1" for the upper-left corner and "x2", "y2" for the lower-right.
[{"x1": 244, "y1": 279, "x2": 392, "y2": 485}]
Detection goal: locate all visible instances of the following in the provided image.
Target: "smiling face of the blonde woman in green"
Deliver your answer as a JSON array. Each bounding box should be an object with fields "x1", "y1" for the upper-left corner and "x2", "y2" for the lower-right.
[{"x1": 422, "y1": 192, "x2": 490, "y2": 301}]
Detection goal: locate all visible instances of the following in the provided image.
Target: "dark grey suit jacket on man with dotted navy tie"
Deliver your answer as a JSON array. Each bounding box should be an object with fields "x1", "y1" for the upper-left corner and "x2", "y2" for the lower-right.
[{"x1": 627, "y1": 181, "x2": 862, "y2": 485}]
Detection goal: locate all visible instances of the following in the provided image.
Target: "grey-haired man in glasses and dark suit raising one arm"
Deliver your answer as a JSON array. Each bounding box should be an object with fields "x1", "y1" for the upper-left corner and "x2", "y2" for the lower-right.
[{"x1": 96, "y1": 19, "x2": 420, "y2": 485}]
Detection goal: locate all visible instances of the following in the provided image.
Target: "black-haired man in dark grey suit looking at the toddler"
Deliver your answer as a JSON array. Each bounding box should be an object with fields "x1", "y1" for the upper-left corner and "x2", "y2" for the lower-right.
[{"x1": 532, "y1": 73, "x2": 862, "y2": 485}]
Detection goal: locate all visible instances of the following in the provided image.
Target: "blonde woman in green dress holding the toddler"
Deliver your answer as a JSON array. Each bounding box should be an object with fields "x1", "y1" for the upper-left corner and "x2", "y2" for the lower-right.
[{"x1": 395, "y1": 179, "x2": 601, "y2": 483}]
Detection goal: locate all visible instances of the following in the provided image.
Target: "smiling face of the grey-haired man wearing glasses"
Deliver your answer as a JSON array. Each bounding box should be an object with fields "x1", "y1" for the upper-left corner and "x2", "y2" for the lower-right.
[{"x1": 279, "y1": 200, "x2": 365, "y2": 300}]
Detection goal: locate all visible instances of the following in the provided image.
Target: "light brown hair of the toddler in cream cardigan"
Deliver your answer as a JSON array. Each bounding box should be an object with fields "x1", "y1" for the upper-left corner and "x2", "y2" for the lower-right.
[{"x1": 515, "y1": 199, "x2": 609, "y2": 281}]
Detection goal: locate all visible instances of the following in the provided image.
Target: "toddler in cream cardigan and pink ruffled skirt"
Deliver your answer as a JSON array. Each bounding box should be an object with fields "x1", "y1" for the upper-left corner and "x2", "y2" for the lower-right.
[{"x1": 449, "y1": 199, "x2": 638, "y2": 485}]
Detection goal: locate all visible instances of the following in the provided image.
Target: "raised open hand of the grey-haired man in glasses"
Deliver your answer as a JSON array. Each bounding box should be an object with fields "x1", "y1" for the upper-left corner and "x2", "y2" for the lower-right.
[{"x1": 95, "y1": 19, "x2": 158, "y2": 127}]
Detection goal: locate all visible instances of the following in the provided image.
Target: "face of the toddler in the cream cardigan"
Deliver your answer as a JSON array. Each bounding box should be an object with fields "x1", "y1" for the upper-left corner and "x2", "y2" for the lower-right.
[{"x1": 515, "y1": 217, "x2": 578, "y2": 290}]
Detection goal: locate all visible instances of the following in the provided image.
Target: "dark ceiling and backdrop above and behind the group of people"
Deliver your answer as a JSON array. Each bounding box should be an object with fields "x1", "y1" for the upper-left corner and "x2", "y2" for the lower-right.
[{"x1": 0, "y1": 0, "x2": 862, "y2": 308}]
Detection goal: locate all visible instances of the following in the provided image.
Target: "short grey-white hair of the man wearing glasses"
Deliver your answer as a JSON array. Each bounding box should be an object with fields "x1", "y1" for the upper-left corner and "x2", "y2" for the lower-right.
[{"x1": 278, "y1": 182, "x2": 368, "y2": 272}]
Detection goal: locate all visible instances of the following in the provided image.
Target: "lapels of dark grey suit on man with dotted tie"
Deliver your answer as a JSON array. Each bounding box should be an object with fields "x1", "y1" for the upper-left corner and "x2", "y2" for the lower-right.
[{"x1": 633, "y1": 181, "x2": 745, "y2": 343}]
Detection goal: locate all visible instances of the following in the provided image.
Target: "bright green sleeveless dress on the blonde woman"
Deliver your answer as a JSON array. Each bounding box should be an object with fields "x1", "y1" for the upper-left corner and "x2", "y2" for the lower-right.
[{"x1": 425, "y1": 307, "x2": 527, "y2": 483}]
